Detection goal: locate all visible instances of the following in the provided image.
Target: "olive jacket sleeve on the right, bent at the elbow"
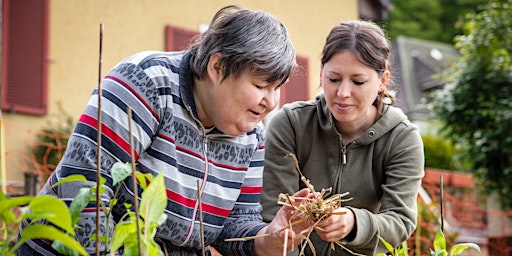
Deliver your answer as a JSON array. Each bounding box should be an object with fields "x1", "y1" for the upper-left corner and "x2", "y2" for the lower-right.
[{"x1": 347, "y1": 124, "x2": 424, "y2": 253}]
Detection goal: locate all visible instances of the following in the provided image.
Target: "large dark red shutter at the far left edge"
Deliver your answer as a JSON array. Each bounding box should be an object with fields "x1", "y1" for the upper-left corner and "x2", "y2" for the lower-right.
[{"x1": 1, "y1": 0, "x2": 48, "y2": 115}]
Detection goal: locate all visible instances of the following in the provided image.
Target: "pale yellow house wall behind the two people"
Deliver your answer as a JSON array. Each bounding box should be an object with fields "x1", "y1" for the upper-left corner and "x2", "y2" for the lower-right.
[{"x1": 3, "y1": 0, "x2": 358, "y2": 187}]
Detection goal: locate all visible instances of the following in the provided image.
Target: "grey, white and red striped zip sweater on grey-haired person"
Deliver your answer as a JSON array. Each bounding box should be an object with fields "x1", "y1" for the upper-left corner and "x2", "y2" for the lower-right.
[{"x1": 21, "y1": 52, "x2": 266, "y2": 255}]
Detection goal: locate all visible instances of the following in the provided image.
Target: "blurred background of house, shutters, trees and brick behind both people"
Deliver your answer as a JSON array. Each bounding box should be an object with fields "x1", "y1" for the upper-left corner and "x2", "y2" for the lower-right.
[{"x1": 0, "y1": 0, "x2": 512, "y2": 255}]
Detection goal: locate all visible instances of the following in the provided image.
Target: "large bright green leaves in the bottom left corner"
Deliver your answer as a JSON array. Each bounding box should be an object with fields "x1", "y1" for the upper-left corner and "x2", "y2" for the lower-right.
[{"x1": 0, "y1": 191, "x2": 89, "y2": 256}]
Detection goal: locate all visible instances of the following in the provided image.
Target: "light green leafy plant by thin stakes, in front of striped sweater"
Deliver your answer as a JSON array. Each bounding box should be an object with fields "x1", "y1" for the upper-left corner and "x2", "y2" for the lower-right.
[{"x1": 52, "y1": 163, "x2": 167, "y2": 256}]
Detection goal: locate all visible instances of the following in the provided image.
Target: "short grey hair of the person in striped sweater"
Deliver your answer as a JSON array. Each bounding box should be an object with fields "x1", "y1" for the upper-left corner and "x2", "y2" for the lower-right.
[{"x1": 188, "y1": 5, "x2": 297, "y2": 84}]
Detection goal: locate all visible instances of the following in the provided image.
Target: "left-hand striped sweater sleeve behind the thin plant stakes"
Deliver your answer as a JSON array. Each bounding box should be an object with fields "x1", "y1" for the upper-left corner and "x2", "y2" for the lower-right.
[{"x1": 45, "y1": 57, "x2": 161, "y2": 253}]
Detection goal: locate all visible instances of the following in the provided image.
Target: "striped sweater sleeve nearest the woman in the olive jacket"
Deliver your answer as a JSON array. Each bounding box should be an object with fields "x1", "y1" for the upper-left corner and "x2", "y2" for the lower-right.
[{"x1": 213, "y1": 123, "x2": 267, "y2": 255}]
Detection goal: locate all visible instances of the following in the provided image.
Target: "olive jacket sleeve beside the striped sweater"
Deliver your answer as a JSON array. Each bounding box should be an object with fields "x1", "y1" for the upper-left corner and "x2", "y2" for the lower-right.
[{"x1": 260, "y1": 106, "x2": 300, "y2": 222}]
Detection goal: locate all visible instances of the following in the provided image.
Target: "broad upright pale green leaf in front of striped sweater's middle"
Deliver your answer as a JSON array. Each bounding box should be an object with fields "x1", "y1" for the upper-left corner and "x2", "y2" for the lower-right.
[{"x1": 140, "y1": 173, "x2": 167, "y2": 224}]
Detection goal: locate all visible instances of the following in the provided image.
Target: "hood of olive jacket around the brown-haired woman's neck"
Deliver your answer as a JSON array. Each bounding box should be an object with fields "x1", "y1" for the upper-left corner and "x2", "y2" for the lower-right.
[{"x1": 315, "y1": 92, "x2": 409, "y2": 145}]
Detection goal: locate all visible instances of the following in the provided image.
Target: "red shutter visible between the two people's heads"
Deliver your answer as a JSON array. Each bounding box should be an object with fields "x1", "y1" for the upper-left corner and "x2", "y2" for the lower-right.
[{"x1": 280, "y1": 56, "x2": 309, "y2": 106}]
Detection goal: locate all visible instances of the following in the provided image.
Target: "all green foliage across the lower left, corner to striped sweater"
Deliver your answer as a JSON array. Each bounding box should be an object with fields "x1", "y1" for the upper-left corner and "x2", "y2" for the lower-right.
[{"x1": 0, "y1": 163, "x2": 167, "y2": 256}]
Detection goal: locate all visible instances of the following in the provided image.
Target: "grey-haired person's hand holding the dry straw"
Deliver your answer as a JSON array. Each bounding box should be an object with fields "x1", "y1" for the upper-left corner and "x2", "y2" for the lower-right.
[{"x1": 254, "y1": 188, "x2": 313, "y2": 255}]
